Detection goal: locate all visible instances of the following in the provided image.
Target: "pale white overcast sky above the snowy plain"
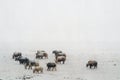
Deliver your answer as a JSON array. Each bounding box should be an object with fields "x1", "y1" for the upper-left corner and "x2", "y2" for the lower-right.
[{"x1": 0, "y1": 0, "x2": 120, "y2": 53}]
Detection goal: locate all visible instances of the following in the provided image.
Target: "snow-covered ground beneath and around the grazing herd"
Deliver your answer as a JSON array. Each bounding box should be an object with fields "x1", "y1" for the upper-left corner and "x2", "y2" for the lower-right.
[{"x1": 0, "y1": 51, "x2": 120, "y2": 80}]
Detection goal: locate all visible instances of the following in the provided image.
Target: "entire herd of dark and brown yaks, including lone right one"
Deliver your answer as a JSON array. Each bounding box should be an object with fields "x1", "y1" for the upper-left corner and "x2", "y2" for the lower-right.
[{"x1": 12, "y1": 50, "x2": 98, "y2": 73}]
